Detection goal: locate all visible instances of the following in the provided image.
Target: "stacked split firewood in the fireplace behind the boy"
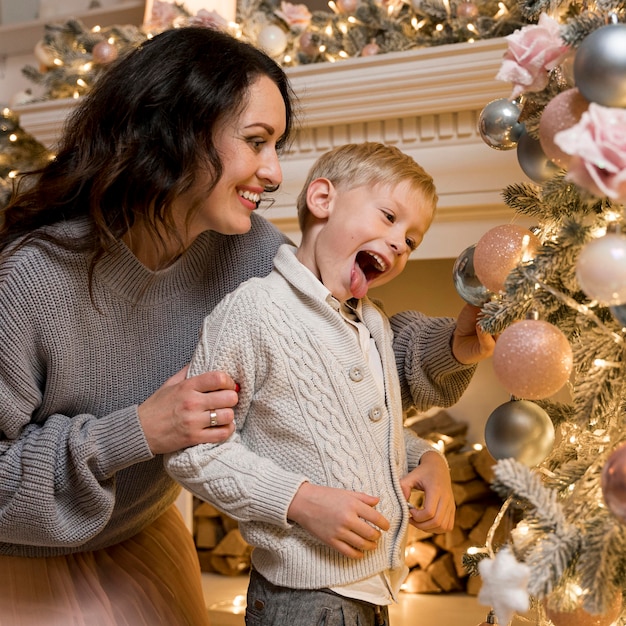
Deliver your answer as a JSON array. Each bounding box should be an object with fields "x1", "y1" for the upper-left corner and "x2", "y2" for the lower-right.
[{"x1": 189, "y1": 411, "x2": 502, "y2": 595}]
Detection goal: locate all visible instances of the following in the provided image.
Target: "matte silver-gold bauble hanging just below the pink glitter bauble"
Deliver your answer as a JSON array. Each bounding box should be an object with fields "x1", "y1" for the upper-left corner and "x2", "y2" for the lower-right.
[{"x1": 485, "y1": 400, "x2": 555, "y2": 467}]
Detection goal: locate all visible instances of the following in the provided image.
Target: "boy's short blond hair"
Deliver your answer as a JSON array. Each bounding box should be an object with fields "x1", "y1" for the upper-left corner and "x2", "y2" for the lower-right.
[{"x1": 297, "y1": 142, "x2": 438, "y2": 230}]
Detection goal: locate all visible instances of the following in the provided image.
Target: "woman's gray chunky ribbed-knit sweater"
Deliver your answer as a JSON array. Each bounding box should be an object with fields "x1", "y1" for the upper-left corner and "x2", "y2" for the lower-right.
[{"x1": 0, "y1": 215, "x2": 285, "y2": 556}]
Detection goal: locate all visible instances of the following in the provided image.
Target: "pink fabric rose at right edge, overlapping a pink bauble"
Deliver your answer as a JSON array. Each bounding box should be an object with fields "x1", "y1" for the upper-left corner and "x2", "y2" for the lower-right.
[{"x1": 554, "y1": 102, "x2": 626, "y2": 202}]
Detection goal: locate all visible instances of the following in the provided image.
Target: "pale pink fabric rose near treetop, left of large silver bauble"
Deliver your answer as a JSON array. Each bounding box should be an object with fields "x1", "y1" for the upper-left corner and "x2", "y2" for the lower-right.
[{"x1": 496, "y1": 13, "x2": 570, "y2": 99}]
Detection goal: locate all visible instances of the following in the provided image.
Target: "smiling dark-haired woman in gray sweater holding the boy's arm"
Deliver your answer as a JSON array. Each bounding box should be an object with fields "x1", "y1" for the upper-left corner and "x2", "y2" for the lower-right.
[{"x1": 0, "y1": 27, "x2": 293, "y2": 626}]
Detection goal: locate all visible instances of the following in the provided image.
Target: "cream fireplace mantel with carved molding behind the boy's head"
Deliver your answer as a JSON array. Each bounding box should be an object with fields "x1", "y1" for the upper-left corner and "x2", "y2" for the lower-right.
[{"x1": 15, "y1": 39, "x2": 528, "y2": 258}]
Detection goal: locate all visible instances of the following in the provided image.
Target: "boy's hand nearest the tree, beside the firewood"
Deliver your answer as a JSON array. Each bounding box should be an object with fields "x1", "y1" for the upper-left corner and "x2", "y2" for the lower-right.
[{"x1": 400, "y1": 452, "x2": 456, "y2": 533}]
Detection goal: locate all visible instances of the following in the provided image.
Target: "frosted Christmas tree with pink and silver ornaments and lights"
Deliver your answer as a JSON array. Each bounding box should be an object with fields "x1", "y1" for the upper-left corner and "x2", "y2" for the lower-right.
[{"x1": 454, "y1": 0, "x2": 626, "y2": 626}]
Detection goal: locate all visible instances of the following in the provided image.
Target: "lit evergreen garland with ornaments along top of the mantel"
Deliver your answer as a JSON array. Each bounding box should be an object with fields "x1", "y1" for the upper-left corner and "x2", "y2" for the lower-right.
[{"x1": 11, "y1": 0, "x2": 535, "y2": 105}]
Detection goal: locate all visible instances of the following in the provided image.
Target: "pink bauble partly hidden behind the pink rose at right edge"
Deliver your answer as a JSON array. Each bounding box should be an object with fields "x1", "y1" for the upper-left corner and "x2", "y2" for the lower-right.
[{"x1": 539, "y1": 88, "x2": 589, "y2": 167}]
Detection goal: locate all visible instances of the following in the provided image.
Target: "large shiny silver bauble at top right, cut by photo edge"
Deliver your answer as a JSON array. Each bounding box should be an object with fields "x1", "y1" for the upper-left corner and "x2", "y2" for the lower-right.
[{"x1": 574, "y1": 24, "x2": 626, "y2": 107}]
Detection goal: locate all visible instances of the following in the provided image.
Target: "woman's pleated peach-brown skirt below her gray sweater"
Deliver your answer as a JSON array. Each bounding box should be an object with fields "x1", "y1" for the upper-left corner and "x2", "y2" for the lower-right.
[{"x1": 0, "y1": 506, "x2": 209, "y2": 626}]
